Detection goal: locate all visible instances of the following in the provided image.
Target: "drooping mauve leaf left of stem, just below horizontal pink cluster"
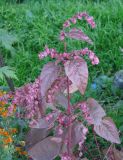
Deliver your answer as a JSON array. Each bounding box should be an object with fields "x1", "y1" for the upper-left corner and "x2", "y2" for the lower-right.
[{"x1": 40, "y1": 62, "x2": 60, "y2": 97}]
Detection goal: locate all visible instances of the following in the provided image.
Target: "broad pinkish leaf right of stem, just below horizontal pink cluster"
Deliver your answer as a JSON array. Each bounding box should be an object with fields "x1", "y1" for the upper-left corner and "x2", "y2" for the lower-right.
[{"x1": 65, "y1": 58, "x2": 88, "y2": 94}]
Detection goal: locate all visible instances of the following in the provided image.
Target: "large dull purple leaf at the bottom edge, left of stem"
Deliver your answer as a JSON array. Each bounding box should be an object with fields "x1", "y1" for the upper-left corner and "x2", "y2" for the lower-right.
[{"x1": 28, "y1": 137, "x2": 61, "y2": 160}]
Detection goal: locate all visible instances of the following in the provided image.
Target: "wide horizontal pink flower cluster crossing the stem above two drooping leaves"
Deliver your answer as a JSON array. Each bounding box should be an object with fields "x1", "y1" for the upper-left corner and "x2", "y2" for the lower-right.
[{"x1": 39, "y1": 48, "x2": 99, "y2": 65}]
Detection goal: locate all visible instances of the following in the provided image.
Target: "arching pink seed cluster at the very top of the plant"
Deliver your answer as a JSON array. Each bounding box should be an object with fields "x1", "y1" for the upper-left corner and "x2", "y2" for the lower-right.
[{"x1": 63, "y1": 12, "x2": 96, "y2": 28}]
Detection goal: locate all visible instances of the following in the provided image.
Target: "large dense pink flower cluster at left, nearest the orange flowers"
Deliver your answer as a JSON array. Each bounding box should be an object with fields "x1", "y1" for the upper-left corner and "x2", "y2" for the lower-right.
[{"x1": 12, "y1": 79, "x2": 41, "y2": 120}]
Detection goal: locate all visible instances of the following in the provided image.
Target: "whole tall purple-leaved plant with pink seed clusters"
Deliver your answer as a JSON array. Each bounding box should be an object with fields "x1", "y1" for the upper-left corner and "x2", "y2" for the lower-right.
[{"x1": 13, "y1": 13, "x2": 120, "y2": 160}]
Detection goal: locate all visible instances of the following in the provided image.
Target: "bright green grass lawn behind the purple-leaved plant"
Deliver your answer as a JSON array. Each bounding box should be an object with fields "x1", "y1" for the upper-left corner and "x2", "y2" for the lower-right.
[{"x1": 0, "y1": 0, "x2": 123, "y2": 158}]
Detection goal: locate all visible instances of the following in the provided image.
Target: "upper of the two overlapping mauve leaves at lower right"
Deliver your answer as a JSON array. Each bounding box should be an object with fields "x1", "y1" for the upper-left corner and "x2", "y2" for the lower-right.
[{"x1": 87, "y1": 98, "x2": 106, "y2": 125}]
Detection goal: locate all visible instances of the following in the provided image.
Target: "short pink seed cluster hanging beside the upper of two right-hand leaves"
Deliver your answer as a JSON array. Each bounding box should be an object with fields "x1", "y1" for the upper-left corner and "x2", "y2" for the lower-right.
[{"x1": 80, "y1": 102, "x2": 92, "y2": 124}]
